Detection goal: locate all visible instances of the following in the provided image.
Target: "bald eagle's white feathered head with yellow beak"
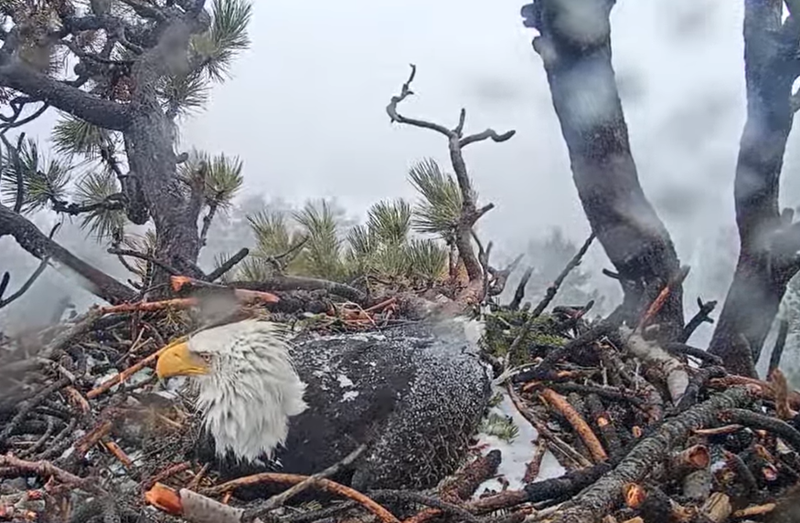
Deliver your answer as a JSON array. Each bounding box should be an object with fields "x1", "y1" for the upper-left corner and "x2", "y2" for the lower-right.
[{"x1": 156, "y1": 320, "x2": 308, "y2": 462}]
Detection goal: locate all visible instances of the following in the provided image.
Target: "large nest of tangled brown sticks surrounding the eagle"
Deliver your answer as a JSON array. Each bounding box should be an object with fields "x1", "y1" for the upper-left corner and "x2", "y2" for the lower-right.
[{"x1": 0, "y1": 286, "x2": 800, "y2": 523}]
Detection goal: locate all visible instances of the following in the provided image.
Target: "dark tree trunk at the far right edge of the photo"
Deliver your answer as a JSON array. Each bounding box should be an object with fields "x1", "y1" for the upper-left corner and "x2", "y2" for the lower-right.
[{"x1": 709, "y1": 0, "x2": 800, "y2": 373}]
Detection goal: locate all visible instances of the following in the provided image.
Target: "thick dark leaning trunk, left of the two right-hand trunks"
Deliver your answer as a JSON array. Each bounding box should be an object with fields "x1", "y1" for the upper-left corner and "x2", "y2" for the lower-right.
[{"x1": 522, "y1": 0, "x2": 683, "y2": 339}]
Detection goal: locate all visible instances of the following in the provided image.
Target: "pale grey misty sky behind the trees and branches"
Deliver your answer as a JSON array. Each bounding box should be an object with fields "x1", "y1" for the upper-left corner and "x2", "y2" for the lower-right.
[{"x1": 0, "y1": 0, "x2": 800, "y2": 360}]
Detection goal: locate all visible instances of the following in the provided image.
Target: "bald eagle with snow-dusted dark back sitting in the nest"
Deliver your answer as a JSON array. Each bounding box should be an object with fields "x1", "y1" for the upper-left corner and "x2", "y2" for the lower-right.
[{"x1": 151, "y1": 320, "x2": 490, "y2": 498}]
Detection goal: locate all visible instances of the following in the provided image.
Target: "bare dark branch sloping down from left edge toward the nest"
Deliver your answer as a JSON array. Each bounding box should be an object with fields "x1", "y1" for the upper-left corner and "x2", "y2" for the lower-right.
[{"x1": 0, "y1": 204, "x2": 136, "y2": 304}]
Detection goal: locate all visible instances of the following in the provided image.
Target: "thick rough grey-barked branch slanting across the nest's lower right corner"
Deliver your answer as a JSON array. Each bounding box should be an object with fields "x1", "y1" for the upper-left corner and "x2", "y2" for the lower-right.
[{"x1": 552, "y1": 387, "x2": 753, "y2": 523}]
